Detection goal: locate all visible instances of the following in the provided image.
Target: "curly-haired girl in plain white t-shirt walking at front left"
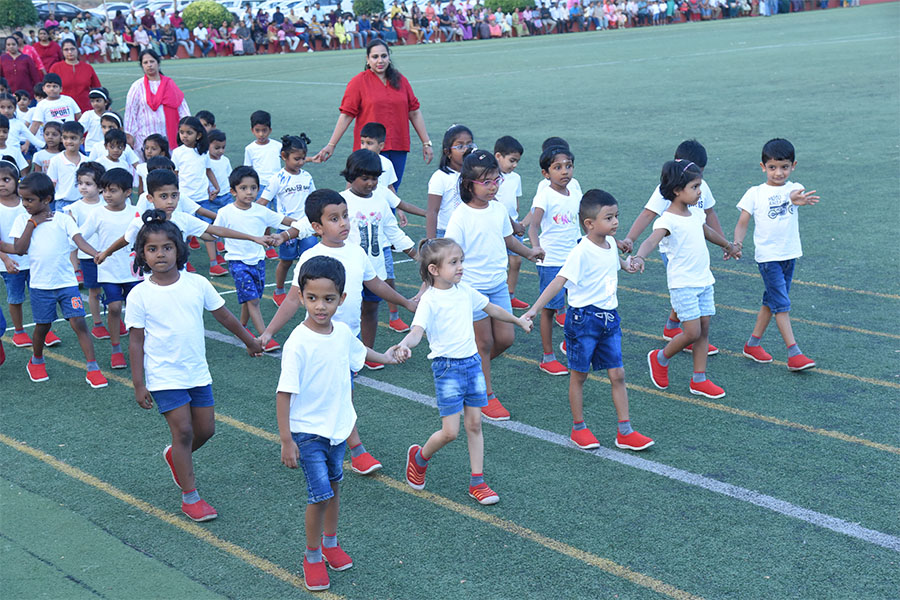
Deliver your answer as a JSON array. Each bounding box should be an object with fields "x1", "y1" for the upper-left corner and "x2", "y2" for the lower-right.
[{"x1": 125, "y1": 210, "x2": 262, "y2": 521}]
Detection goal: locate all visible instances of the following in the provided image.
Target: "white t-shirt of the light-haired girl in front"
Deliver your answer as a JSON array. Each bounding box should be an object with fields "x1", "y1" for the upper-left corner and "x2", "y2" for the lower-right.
[{"x1": 412, "y1": 283, "x2": 488, "y2": 359}]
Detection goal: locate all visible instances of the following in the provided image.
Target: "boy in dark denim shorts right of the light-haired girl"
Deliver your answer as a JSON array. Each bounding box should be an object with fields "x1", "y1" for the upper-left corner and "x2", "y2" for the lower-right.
[{"x1": 525, "y1": 190, "x2": 653, "y2": 450}]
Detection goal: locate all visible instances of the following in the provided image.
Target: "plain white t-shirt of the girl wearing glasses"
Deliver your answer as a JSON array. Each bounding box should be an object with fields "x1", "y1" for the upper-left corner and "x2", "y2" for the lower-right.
[{"x1": 444, "y1": 202, "x2": 512, "y2": 290}]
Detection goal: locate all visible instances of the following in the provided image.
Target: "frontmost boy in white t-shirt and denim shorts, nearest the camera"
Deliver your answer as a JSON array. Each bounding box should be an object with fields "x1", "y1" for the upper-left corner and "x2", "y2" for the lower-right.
[{"x1": 276, "y1": 256, "x2": 397, "y2": 590}]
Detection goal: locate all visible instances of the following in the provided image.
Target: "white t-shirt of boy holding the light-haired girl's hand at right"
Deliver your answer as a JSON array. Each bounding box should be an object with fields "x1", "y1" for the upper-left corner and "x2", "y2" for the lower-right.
[{"x1": 559, "y1": 236, "x2": 621, "y2": 310}]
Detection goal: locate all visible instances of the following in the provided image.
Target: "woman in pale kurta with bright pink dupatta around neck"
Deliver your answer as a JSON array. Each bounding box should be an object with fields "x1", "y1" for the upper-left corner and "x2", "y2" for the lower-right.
[{"x1": 125, "y1": 48, "x2": 191, "y2": 156}]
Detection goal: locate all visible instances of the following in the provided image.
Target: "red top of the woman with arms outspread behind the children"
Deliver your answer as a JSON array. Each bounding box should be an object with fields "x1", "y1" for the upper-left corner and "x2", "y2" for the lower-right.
[{"x1": 339, "y1": 69, "x2": 419, "y2": 152}]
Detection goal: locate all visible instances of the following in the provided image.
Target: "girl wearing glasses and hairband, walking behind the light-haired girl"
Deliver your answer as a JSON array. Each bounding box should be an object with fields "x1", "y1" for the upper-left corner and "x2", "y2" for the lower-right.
[{"x1": 445, "y1": 150, "x2": 544, "y2": 421}]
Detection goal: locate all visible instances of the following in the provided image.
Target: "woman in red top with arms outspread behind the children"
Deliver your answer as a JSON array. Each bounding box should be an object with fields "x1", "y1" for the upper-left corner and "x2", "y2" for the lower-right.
[{"x1": 312, "y1": 39, "x2": 434, "y2": 189}]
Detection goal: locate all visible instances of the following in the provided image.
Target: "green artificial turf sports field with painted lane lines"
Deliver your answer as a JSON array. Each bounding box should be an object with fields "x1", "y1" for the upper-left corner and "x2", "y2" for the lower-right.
[{"x1": 0, "y1": 3, "x2": 900, "y2": 600}]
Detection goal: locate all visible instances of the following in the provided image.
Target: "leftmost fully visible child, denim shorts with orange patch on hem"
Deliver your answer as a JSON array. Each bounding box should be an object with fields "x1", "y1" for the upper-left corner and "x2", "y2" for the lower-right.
[{"x1": 9, "y1": 173, "x2": 107, "y2": 388}]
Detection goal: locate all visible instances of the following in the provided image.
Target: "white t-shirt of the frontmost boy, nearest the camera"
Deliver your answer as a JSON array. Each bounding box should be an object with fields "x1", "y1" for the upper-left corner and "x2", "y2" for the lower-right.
[{"x1": 278, "y1": 321, "x2": 366, "y2": 446}]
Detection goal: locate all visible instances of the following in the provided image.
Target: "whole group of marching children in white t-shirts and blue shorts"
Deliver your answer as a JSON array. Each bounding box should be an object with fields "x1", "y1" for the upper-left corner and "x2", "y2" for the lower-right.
[{"x1": 0, "y1": 81, "x2": 818, "y2": 589}]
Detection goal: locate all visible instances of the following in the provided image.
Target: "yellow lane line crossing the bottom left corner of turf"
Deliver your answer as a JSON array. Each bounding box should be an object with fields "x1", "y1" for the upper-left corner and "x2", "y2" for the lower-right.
[{"x1": 0, "y1": 433, "x2": 344, "y2": 600}]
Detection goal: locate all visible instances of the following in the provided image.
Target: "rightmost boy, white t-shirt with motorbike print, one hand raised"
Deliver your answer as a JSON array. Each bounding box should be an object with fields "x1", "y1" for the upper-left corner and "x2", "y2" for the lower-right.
[{"x1": 734, "y1": 138, "x2": 819, "y2": 371}]
